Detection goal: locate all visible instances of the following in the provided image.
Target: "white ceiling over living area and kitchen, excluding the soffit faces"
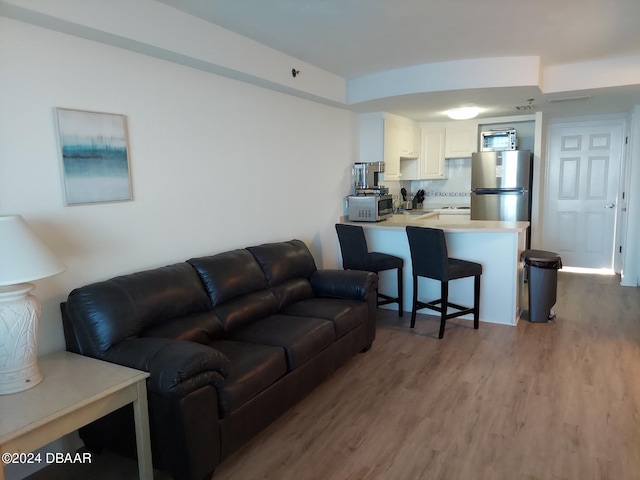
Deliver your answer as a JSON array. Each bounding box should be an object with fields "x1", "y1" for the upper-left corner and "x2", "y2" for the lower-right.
[{"x1": 158, "y1": 0, "x2": 640, "y2": 121}]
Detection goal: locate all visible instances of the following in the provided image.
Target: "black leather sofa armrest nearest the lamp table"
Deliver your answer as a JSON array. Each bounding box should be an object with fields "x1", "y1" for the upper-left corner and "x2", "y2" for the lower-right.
[{"x1": 102, "y1": 337, "x2": 231, "y2": 397}]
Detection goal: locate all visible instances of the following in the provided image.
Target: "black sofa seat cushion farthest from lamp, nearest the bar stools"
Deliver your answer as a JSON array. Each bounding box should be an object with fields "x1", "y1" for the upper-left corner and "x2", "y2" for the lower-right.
[{"x1": 280, "y1": 298, "x2": 368, "y2": 338}]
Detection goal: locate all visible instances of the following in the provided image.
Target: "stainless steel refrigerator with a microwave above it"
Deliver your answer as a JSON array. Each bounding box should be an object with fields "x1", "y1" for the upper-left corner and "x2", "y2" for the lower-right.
[{"x1": 471, "y1": 150, "x2": 533, "y2": 244}]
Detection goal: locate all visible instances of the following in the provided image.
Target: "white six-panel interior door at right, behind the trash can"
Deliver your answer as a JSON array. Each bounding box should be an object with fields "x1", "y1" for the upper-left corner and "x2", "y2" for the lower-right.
[{"x1": 543, "y1": 122, "x2": 623, "y2": 269}]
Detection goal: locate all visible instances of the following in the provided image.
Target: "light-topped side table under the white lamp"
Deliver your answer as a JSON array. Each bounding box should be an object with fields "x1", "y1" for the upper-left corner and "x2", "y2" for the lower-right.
[{"x1": 0, "y1": 351, "x2": 153, "y2": 480}]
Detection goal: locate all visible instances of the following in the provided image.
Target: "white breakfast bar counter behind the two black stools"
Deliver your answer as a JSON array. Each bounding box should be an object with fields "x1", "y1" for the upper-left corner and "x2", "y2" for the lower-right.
[{"x1": 340, "y1": 217, "x2": 529, "y2": 325}]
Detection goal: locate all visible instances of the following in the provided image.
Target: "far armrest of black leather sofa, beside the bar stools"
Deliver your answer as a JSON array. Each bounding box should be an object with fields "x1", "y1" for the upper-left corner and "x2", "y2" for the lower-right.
[{"x1": 309, "y1": 270, "x2": 378, "y2": 300}]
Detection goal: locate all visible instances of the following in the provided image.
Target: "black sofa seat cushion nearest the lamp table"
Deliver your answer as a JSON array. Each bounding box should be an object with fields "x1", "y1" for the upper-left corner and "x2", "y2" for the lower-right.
[{"x1": 211, "y1": 340, "x2": 287, "y2": 418}]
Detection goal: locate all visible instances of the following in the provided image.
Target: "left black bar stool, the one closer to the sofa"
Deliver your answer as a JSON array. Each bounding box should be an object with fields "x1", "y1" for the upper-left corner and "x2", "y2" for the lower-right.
[{"x1": 336, "y1": 223, "x2": 404, "y2": 317}]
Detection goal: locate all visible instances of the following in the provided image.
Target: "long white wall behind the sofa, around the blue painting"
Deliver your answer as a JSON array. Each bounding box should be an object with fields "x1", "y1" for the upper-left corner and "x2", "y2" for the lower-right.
[{"x1": 0, "y1": 17, "x2": 357, "y2": 354}]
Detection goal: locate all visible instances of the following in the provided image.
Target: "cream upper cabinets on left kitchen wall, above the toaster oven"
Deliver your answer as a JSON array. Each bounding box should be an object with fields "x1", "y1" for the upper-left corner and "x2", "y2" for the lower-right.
[{"x1": 360, "y1": 113, "x2": 420, "y2": 180}]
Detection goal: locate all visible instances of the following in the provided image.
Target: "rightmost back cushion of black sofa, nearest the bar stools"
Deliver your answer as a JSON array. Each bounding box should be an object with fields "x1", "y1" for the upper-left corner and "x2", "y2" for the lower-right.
[{"x1": 247, "y1": 240, "x2": 317, "y2": 309}]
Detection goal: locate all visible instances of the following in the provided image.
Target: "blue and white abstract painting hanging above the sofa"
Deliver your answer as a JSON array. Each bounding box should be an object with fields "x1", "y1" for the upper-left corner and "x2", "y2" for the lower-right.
[{"x1": 56, "y1": 108, "x2": 132, "y2": 205}]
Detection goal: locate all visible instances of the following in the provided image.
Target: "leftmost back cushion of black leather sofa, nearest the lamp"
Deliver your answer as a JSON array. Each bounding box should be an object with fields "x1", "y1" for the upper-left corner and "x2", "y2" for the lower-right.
[{"x1": 65, "y1": 263, "x2": 222, "y2": 357}]
